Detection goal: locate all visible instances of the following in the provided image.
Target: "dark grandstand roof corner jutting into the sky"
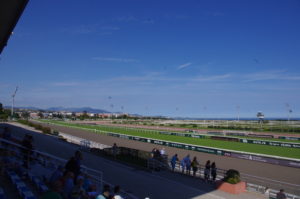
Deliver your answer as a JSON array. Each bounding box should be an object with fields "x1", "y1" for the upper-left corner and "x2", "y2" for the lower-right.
[{"x1": 0, "y1": 0, "x2": 29, "y2": 54}]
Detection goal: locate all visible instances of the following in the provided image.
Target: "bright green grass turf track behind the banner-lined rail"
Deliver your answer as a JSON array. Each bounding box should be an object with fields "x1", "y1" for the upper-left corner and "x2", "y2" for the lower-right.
[{"x1": 41, "y1": 121, "x2": 300, "y2": 159}]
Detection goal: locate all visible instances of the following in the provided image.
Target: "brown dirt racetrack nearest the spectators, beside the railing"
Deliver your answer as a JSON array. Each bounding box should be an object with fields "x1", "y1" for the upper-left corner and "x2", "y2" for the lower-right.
[{"x1": 36, "y1": 124, "x2": 300, "y2": 195}]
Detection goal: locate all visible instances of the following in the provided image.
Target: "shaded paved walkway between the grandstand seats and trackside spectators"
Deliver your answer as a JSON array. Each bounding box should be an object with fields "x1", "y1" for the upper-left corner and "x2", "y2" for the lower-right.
[{"x1": 1, "y1": 125, "x2": 267, "y2": 199}]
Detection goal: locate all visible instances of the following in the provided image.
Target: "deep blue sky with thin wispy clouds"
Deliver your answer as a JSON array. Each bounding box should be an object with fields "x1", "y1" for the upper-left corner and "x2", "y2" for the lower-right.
[{"x1": 0, "y1": 0, "x2": 300, "y2": 117}]
